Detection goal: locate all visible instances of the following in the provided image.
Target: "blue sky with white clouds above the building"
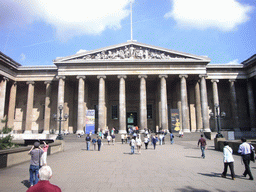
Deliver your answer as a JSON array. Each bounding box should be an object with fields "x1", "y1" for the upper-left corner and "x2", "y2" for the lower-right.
[{"x1": 0, "y1": 0, "x2": 256, "y2": 66}]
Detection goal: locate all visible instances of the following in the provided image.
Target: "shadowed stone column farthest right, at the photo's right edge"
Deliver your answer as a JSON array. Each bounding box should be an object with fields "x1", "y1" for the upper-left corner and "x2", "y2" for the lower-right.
[{"x1": 247, "y1": 79, "x2": 256, "y2": 128}]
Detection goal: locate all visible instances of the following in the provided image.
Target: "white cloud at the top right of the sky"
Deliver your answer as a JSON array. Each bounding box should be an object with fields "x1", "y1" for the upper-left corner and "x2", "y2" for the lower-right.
[{"x1": 165, "y1": 0, "x2": 254, "y2": 31}]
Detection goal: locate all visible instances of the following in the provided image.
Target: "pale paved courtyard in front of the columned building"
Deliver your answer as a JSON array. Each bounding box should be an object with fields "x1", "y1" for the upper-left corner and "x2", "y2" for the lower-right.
[{"x1": 0, "y1": 138, "x2": 256, "y2": 192}]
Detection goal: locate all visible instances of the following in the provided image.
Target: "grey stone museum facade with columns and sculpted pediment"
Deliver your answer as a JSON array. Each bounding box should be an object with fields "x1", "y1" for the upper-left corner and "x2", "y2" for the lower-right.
[{"x1": 0, "y1": 41, "x2": 256, "y2": 136}]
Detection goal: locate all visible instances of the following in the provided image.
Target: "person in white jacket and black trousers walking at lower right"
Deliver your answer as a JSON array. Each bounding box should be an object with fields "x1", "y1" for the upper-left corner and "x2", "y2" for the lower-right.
[{"x1": 221, "y1": 141, "x2": 235, "y2": 180}]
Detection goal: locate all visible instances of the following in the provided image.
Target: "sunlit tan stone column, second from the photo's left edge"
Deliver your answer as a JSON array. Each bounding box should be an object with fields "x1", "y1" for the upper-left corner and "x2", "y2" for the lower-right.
[{"x1": 7, "y1": 82, "x2": 17, "y2": 131}]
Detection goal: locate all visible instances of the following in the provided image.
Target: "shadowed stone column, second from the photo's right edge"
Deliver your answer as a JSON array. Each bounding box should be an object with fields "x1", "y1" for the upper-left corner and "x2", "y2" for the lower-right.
[{"x1": 229, "y1": 79, "x2": 239, "y2": 130}]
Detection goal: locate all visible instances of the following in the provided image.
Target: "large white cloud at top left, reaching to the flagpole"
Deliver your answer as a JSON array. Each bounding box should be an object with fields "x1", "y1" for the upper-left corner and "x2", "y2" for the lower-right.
[{"x1": 0, "y1": 0, "x2": 134, "y2": 40}]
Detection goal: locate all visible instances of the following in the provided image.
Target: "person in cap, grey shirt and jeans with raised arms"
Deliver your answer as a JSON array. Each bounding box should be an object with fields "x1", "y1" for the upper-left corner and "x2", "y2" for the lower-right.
[{"x1": 28, "y1": 141, "x2": 44, "y2": 186}]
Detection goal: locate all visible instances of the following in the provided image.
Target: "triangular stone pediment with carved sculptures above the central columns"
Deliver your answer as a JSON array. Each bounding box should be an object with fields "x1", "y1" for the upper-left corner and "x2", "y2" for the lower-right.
[{"x1": 54, "y1": 41, "x2": 210, "y2": 63}]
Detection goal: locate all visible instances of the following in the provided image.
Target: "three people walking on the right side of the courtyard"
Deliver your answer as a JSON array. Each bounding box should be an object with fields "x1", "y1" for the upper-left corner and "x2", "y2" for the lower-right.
[{"x1": 198, "y1": 135, "x2": 255, "y2": 180}]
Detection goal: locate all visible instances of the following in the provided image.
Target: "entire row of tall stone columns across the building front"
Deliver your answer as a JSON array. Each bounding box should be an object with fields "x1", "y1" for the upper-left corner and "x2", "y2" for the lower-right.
[{"x1": 0, "y1": 75, "x2": 256, "y2": 133}]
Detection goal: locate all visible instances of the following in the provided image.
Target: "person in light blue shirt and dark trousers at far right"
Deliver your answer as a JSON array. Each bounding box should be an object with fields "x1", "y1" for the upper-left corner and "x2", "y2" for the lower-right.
[{"x1": 238, "y1": 137, "x2": 254, "y2": 180}]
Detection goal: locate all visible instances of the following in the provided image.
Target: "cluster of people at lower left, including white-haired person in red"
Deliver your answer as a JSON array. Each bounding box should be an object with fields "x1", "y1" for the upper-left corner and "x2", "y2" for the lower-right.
[{"x1": 27, "y1": 141, "x2": 61, "y2": 192}]
